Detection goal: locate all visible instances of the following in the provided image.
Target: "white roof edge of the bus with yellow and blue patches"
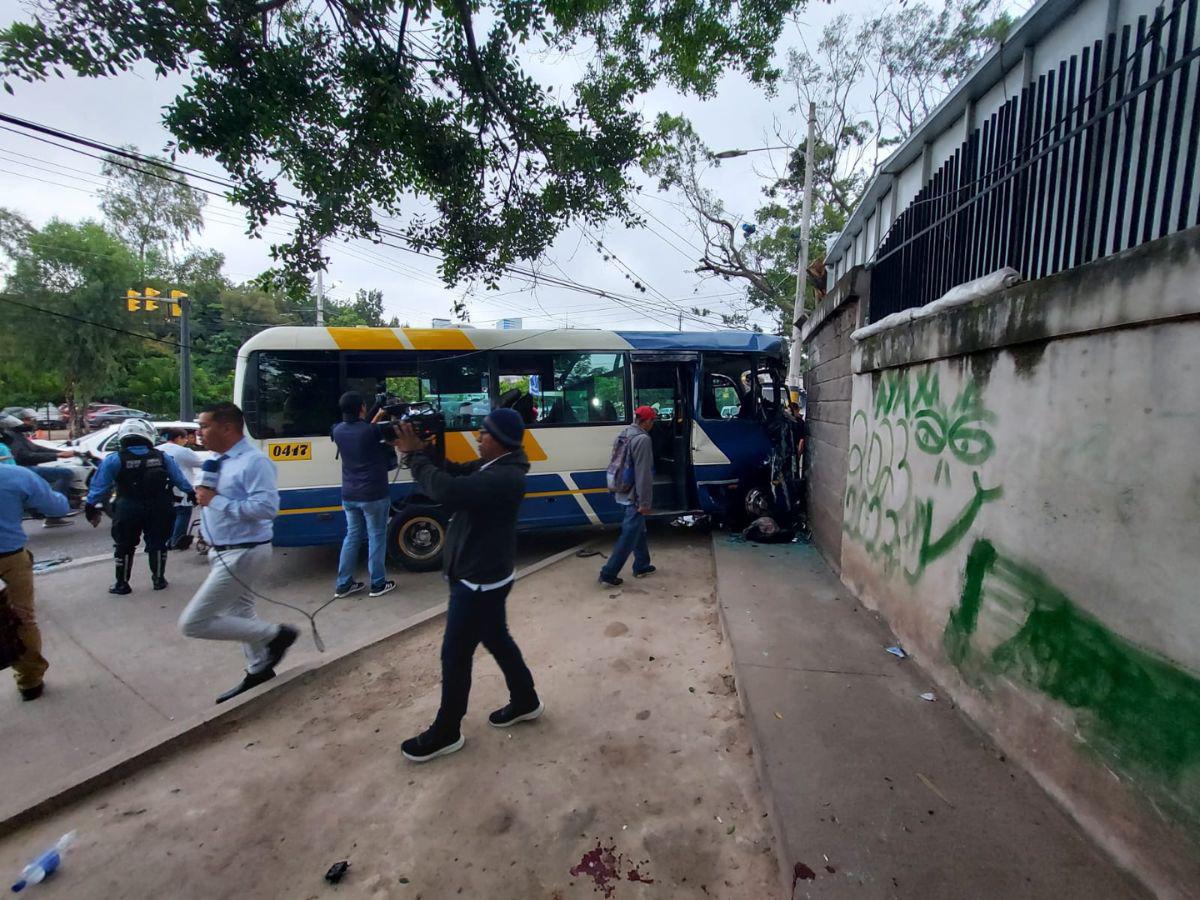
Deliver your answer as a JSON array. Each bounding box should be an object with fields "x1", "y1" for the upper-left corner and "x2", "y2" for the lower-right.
[{"x1": 240, "y1": 325, "x2": 784, "y2": 355}]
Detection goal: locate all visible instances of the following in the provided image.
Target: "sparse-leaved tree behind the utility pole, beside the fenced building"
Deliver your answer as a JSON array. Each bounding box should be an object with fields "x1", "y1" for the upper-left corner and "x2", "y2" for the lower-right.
[{"x1": 643, "y1": 0, "x2": 1012, "y2": 334}]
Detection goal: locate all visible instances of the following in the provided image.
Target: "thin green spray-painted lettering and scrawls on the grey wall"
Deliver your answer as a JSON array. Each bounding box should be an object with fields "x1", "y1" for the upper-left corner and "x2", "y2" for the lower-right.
[{"x1": 842, "y1": 366, "x2": 1002, "y2": 582}]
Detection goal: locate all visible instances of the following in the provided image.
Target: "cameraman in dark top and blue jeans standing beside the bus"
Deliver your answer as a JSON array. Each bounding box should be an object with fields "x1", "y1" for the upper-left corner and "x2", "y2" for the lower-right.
[{"x1": 334, "y1": 391, "x2": 396, "y2": 599}]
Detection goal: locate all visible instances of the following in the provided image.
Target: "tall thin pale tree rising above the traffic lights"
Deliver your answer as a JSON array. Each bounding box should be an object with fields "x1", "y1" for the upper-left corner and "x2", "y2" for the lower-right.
[{"x1": 100, "y1": 146, "x2": 206, "y2": 278}]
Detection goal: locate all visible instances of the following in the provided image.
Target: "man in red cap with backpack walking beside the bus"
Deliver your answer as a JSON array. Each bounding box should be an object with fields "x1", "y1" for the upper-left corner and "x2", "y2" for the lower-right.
[{"x1": 600, "y1": 407, "x2": 659, "y2": 587}]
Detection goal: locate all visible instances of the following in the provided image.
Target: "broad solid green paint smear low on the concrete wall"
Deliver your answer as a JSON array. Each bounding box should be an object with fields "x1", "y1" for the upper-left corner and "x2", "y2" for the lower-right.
[{"x1": 942, "y1": 540, "x2": 1200, "y2": 816}]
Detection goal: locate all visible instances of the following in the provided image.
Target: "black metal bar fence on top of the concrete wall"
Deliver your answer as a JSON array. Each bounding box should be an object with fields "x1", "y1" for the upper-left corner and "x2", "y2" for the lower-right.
[{"x1": 870, "y1": 0, "x2": 1200, "y2": 322}]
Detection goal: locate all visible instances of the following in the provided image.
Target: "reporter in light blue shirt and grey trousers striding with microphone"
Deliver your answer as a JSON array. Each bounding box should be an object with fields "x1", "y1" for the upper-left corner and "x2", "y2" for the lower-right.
[{"x1": 179, "y1": 403, "x2": 299, "y2": 703}]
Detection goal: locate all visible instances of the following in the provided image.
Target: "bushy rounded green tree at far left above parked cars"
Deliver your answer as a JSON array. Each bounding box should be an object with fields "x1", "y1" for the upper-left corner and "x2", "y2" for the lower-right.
[{"x1": 5, "y1": 220, "x2": 138, "y2": 433}]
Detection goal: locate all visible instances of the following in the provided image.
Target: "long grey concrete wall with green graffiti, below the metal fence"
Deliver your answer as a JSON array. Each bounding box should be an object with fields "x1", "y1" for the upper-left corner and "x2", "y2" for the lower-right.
[{"x1": 840, "y1": 228, "x2": 1200, "y2": 896}]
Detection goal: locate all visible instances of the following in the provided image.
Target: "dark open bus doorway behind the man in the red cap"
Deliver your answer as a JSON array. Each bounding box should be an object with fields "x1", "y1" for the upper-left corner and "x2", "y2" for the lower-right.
[{"x1": 634, "y1": 353, "x2": 696, "y2": 512}]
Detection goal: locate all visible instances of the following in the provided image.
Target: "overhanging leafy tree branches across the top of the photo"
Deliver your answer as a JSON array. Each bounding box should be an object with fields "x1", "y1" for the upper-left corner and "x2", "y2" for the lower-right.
[{"x1": 0, "y1": 0, "x2": 804, "y2": 289}]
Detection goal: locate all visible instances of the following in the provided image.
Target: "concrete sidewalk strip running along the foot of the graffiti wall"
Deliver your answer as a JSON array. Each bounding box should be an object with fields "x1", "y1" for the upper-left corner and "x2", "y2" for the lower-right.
[{"x1": 713, "y1": 534, "x2": 1146, "y2": 900}]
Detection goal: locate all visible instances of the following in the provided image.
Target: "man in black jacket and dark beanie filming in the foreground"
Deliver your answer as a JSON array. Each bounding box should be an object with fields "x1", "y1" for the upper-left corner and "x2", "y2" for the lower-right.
[{"x1": 396, "y1": 409, "x2": 544, "y2": 762}]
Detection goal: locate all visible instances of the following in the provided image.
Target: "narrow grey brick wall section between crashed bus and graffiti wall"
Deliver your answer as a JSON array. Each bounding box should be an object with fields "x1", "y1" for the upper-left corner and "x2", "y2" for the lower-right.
[{"x1": 804, "y1": 298, "x2": 859, "y2": 570}]
